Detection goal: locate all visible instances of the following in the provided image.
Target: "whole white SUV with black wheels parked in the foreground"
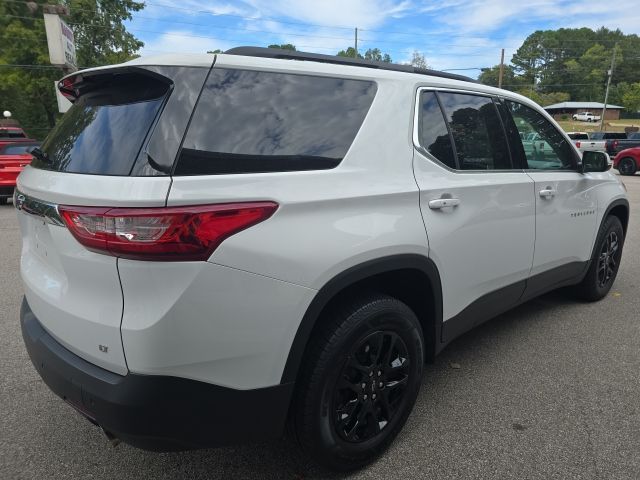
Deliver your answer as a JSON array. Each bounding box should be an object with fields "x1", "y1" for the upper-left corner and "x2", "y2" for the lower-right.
[{"x1": 15, "y1": 47, "x2": 629, "y2": 470}]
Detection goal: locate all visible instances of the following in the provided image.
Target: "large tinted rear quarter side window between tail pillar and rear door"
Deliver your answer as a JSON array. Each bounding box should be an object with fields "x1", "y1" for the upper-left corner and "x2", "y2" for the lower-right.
[{"x1": 175, "y1": 68, "x2": 376, "y2": 175}]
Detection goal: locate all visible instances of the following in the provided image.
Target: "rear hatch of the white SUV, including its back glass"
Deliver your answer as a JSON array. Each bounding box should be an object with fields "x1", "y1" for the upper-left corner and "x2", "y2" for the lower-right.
[{"x1": 14, "y1": 61, "x2": 208, "y2": 374}]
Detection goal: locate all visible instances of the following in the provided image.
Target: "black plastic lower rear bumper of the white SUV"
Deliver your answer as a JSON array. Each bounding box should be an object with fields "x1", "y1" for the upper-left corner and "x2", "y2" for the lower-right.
[{"x1": 20, "y1": 300, "x2": 293, "y2": 451}]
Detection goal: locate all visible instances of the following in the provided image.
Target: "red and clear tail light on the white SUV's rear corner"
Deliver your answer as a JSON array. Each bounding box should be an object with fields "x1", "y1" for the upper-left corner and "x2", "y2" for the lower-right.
[{"x1": 59, "y1": 202, "x2": 278, "y2": 261}]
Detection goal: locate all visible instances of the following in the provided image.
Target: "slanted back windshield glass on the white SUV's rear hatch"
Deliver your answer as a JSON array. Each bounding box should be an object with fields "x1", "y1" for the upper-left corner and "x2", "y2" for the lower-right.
[{"x1": 32, "y1": 73, "x2": 169, "y2": 175}]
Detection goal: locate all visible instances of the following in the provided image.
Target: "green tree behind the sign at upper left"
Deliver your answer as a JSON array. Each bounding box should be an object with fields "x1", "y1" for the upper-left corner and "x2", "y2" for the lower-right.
[{"x1": 0, "y1": 0, "x2": 144, "y2": 138}]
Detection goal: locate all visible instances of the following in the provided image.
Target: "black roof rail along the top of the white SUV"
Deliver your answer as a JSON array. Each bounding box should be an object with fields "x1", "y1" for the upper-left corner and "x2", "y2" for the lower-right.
[{"x1": 224, "y1": 47, "x2": 478, "y2": 83}]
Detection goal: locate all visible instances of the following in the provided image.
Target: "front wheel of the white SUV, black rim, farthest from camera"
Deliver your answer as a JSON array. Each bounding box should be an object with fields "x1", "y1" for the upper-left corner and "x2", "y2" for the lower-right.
[{"x1": 575, "y1": 215, "x2": 624, "y2": 302}]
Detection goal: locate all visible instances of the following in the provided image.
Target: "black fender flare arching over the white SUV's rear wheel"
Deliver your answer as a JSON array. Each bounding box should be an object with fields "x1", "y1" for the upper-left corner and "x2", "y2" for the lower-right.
[{"x1": 280, "y1": 254, "x2": 442, "y2": 383}]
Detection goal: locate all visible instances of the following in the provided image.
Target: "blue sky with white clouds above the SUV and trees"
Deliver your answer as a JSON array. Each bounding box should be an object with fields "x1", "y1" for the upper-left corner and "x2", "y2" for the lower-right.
[{"x1": 127, "y1": 0, "x2": 640, "y2": 77}]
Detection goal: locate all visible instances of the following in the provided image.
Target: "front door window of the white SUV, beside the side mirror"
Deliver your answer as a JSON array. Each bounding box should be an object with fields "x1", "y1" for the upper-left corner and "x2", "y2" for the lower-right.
[{"x1": 505, "y1": 100, "x2": 577, "y2": 170}]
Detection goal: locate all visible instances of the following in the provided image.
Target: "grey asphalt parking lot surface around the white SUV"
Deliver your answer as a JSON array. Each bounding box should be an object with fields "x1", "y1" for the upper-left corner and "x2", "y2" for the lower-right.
[{"x1": 0, "y1": 175, "x2": 640, "y2": 479}]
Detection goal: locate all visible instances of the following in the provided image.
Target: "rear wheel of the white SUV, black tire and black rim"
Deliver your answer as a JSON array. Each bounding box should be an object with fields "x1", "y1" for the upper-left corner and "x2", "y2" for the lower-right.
[{"x1": 293, "y1": 294, "x2": 424, "y2": 471}]
